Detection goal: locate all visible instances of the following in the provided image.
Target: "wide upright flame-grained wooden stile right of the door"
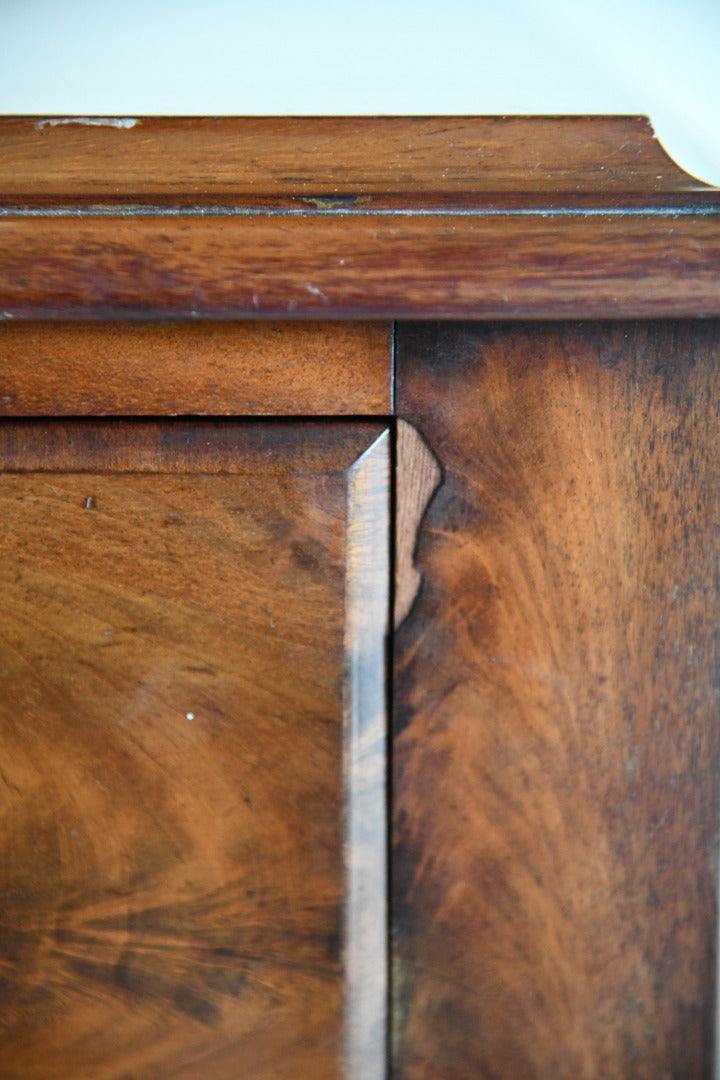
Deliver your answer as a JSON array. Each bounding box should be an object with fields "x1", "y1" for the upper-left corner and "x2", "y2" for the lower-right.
[{"x1": 394, "y1": 321, "x2": 720, "y2": 1080}]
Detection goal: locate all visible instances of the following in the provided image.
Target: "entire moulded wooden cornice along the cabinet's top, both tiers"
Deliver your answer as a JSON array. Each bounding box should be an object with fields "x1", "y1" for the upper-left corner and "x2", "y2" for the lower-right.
[{"x1": 0, "y1": 117, "x2": 720, "y2": 320}]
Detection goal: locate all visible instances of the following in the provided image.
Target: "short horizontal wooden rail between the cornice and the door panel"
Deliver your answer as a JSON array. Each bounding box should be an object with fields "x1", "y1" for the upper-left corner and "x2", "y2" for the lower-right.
[{"x1": 0, "y1": 321, "x2": 391, "y2": 416}]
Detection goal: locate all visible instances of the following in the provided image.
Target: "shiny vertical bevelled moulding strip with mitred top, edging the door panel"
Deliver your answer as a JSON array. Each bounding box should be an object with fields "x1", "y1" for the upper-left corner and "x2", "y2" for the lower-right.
[{"x1": 343, "y1": 430, "x2": 391, "y2": 1080}]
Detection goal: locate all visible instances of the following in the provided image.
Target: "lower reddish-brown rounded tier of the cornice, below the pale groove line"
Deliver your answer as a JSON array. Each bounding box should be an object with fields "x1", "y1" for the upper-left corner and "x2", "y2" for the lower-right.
[{"x1": 0, "y1": 203, "x2": 720, "y2": 320}]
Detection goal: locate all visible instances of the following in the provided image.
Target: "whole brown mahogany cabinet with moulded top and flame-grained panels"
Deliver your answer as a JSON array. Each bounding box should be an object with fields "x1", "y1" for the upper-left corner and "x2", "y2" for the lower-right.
[{"x1": 0, "y1": 117, "x2": 720, "y2": 1080}]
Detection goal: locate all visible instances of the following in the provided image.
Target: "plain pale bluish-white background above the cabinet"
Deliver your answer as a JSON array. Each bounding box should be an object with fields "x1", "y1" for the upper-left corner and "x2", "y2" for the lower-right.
[{"x1": 0, "y1": 0, "x2": 720, "y2": 185}]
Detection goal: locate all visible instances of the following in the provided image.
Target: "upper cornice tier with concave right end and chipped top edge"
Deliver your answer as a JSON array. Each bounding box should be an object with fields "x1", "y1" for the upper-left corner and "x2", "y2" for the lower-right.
[{"x1": 0, "y1": 117, "x2": 703, "y2": 200}]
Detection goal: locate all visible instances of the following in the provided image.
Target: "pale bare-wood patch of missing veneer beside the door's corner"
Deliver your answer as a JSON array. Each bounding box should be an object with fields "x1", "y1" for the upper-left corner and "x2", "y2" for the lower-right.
[{"x1": 395, "y1": 420, "x2": 443, "y2": 627}]
